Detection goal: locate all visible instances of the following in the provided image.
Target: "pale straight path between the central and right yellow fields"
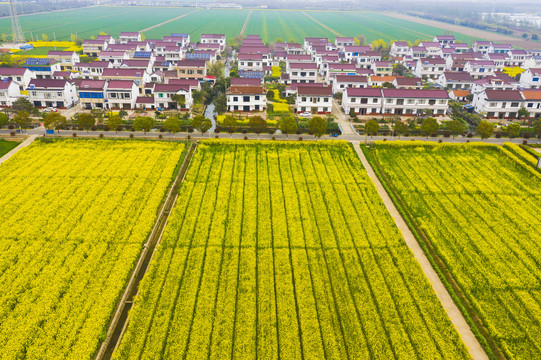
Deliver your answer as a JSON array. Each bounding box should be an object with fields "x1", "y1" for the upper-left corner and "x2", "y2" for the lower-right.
[{"x1": 353, "y1": 142, "x2": 488, "y2": 360}]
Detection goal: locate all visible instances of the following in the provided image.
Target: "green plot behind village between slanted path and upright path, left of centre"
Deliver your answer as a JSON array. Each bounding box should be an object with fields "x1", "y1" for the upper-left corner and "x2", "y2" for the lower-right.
[{"x1": 141, "y1": 9, "x2": 249, "y2": 41}]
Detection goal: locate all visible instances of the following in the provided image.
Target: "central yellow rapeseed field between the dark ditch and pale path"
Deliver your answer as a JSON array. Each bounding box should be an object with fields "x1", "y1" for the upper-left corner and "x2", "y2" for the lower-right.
[{"x1": 113, "y1": 140, "x2": 468, "y2": 359}]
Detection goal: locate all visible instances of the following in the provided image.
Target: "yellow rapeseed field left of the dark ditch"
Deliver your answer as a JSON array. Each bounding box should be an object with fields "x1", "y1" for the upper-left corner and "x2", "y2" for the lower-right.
[{"x1": 0, "y1": 140, "x2": 184, "y2": 359}]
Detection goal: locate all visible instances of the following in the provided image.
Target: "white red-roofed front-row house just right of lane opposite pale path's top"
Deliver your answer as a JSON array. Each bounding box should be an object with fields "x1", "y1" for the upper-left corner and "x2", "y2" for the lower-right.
[{"x1": 342, "y1": 88, "x2": 383, "y2": 115}]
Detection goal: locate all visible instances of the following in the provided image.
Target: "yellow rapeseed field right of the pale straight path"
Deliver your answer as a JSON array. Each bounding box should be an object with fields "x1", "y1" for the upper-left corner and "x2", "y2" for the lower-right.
[{"x1": 374, "y1": 142, "x2": 541, "y2": 359}]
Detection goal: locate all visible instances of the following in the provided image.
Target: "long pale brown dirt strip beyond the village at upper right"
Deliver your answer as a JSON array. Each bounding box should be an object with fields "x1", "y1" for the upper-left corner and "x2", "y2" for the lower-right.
[{"x1": 385, "y1": 13, "x2": 541, "y2": 49}]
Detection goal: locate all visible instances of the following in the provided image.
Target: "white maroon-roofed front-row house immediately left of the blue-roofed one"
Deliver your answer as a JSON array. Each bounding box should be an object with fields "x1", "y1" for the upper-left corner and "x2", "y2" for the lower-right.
[{"x1": 28, "y1": 79, "x2": 79, "y2": 109}]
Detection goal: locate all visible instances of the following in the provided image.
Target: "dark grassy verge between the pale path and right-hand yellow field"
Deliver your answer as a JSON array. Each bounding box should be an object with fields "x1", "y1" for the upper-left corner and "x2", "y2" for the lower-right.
[{"x1": 361, "y1": 145, "x2": 506, "y2": 359}]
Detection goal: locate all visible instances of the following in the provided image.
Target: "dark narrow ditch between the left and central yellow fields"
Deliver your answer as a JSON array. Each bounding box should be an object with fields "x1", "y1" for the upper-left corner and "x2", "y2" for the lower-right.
[{"x1": 95, "y1": 143, "x2": 197, "y2": 360}]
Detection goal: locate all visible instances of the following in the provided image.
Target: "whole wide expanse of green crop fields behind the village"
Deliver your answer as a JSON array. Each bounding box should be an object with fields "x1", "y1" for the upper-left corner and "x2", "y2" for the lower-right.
[{"x1": 0, "y1": 6, "x2": 486, "y2": 42}]
